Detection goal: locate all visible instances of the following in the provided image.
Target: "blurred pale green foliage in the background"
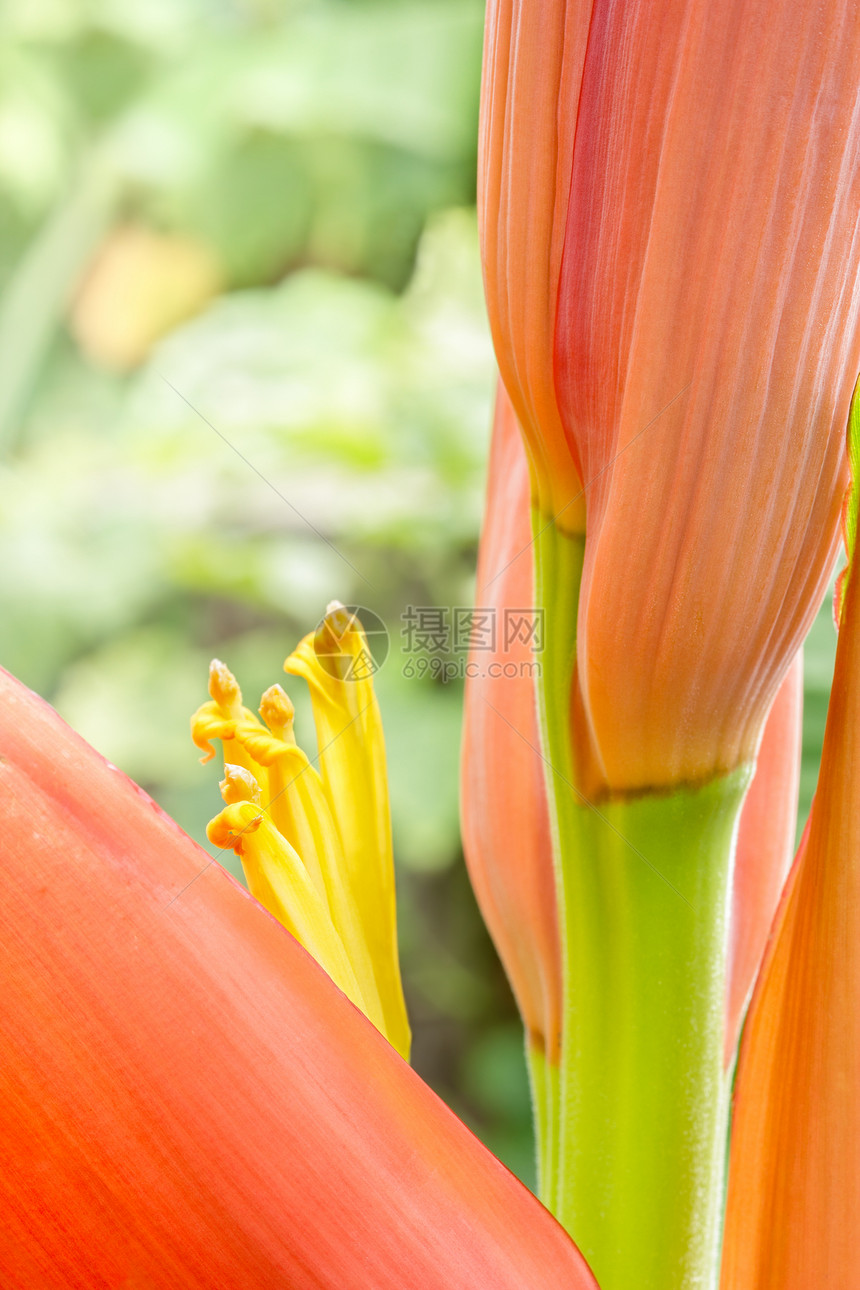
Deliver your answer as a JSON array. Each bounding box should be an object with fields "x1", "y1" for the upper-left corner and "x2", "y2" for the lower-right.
[{"x1": 0, "y1": 0, "x2": 836, "y2": 1197}]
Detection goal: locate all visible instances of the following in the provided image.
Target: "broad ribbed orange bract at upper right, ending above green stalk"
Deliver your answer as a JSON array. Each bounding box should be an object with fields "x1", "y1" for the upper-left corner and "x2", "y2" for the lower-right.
[{"x1": 551, "y1": 0, "x2": 860, "y2": 789}]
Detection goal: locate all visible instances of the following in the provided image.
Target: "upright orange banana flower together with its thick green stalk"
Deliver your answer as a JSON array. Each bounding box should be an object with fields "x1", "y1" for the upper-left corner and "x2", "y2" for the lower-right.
[{"x1": 480, "y1": 0, "x2": 860, "y2": 1290}]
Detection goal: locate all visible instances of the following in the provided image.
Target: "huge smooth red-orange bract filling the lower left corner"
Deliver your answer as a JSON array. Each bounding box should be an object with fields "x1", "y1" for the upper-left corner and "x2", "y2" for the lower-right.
[{"x1": 0, "y1": 673, "x2": 593, "y2": 1290}]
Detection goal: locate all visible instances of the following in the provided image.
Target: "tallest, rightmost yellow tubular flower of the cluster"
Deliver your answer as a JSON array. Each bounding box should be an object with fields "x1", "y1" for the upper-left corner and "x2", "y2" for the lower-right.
[{"x1": 284, "y1": 601, "x2": 410, "y2": 1053}]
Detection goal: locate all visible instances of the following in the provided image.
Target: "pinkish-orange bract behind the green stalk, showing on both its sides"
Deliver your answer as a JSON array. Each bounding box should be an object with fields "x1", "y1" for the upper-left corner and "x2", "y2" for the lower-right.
[{"x1": 462, "y1": 384, "x2": 803, "y2": 1064}]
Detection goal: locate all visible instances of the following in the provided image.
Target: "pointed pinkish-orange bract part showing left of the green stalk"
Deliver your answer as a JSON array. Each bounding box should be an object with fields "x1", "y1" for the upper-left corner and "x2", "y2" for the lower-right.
[{"x1": 462, "y1": 384, "x2": 561, "y2": 1062}]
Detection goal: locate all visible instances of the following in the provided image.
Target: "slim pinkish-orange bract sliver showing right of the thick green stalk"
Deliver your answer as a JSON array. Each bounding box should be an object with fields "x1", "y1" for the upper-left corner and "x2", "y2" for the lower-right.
[{"x1": 726, "y1": 653, "x2": 803, "y2": 1064}]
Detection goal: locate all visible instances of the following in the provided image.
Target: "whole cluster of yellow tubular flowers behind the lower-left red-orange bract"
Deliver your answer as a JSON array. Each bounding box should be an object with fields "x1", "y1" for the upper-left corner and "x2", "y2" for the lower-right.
[{"x1": 191, "y1": 608, "x2": 410, "y2": 1058}]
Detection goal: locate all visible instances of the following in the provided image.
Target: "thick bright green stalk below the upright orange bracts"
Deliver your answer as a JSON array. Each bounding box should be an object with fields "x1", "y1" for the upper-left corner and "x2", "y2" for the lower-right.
[{"x1": 535, "y1": 522, "x2": 750, "y2": 1290}]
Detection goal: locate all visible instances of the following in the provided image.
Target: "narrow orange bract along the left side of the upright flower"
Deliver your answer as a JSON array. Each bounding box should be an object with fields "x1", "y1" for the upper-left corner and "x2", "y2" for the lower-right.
[{"x1": 478, "y1": 0, "x2": 588, "y2": 531}]
